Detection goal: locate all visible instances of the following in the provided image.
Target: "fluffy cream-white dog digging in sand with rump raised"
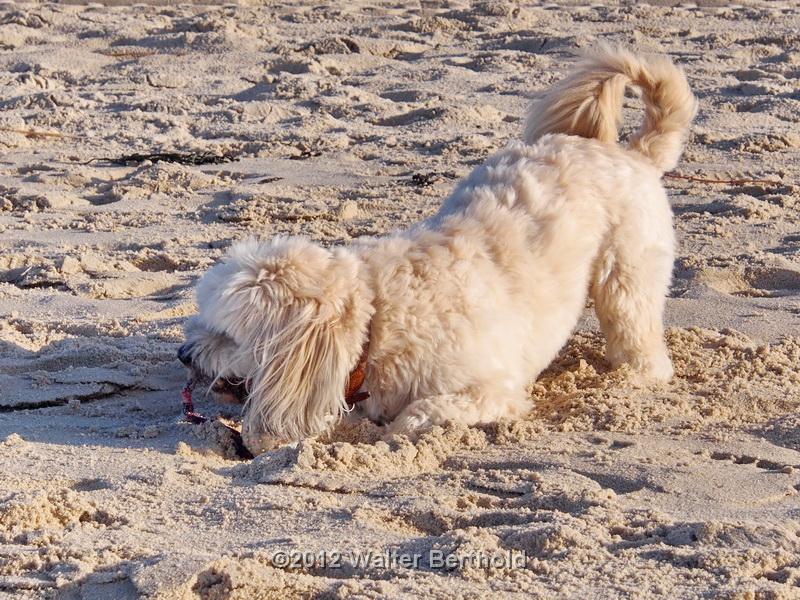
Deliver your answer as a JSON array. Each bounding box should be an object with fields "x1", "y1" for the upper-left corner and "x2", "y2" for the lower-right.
[{"x1": 179, "y1": 48, "x2": 695, "y2": 452}]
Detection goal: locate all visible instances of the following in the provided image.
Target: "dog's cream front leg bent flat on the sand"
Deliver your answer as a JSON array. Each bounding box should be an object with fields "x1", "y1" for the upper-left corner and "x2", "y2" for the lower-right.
[{"x1": 386, "y1": 392, "x2": 530, "y2": 437}]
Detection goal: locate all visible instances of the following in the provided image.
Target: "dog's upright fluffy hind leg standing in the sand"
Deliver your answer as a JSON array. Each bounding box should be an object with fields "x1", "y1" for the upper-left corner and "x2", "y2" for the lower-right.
[{"x1": 591, "y1": 224, "x2": 674, "y2": 382}]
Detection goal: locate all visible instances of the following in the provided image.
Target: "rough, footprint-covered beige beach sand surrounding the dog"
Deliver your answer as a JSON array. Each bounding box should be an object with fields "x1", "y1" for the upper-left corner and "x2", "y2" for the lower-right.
[{"x1": 0, "y1": 1, "x2": 800, "y2": 599}]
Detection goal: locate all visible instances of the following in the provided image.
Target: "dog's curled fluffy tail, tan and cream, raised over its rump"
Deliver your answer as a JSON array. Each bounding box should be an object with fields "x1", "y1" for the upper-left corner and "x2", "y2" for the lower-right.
[{"x1": 525, "y1": 46, "x2": 696, "y2": 172}]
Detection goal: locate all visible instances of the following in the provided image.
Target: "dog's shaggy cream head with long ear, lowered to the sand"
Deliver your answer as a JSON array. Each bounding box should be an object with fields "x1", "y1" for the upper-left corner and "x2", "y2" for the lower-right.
[{"x1": 178, "y1": 237, "x2": 372, "y2": 452}]
